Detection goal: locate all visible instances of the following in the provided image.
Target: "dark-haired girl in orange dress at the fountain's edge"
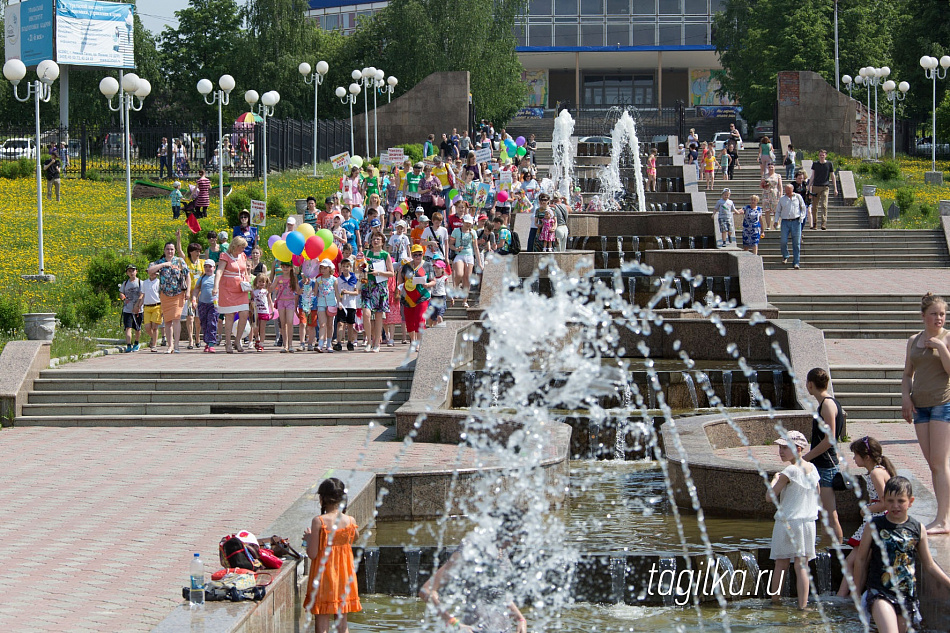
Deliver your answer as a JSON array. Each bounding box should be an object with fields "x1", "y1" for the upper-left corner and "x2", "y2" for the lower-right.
[{"x1": 304, "y1": 477, "x2": 363, "y2": 633}]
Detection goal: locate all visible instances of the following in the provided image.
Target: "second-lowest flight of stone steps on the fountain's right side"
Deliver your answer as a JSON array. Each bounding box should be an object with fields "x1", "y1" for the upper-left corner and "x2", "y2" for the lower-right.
[{"x1": 769, "y1": 294, "x2": 920, "y2": 340}]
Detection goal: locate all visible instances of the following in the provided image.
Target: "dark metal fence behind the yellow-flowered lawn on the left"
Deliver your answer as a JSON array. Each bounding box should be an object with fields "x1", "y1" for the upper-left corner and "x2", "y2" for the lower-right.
[{"x1": 0, "y1": 119, "x2": 350, "y2": 180}]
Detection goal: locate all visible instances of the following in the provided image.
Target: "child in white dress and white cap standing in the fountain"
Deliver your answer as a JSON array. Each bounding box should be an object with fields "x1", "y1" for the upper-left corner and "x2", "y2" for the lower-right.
[{"x1": 766, "y1": 431, "x2": 818, "y2": 609}]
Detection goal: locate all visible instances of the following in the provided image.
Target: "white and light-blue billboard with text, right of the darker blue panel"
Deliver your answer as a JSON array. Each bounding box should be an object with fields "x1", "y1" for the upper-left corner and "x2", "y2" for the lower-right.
[{"x1": 55, "y1": 0, "x2": 135, "y2": 68}]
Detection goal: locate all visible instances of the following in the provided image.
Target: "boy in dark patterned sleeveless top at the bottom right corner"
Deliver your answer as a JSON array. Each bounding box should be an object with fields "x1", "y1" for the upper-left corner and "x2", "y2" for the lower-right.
[{"x1": 854, "y1": 476, "x2": 950, "y2": 633}]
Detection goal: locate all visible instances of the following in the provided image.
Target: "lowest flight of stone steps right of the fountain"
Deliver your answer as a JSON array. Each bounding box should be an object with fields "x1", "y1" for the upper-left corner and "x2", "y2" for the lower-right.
[{"x1": 831, "y1": 365, "x2": 904, "y2": 422}]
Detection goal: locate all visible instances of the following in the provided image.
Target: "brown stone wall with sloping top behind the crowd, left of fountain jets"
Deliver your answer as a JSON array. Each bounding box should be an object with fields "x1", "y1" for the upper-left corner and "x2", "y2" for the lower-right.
[{"x1": 353, "y1": 70, "x2": 469, "y2": 156}]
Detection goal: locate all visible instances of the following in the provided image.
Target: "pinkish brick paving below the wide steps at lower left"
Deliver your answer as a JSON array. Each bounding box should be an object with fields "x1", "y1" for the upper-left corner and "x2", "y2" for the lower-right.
[{"x1": 0, "y1": 427, "x2": 490, "y2": 633}]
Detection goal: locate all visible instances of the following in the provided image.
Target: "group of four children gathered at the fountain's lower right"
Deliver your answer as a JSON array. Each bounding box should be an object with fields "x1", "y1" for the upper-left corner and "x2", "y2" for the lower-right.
[{"x1": 766, "y1": 368, "x2": 950, "y2": 633}]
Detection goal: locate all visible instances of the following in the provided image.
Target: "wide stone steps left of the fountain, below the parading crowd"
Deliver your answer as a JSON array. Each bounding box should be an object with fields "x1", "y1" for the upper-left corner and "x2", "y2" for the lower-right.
[{"x1": 14, "y1": 367, "x2": 413, "y2": 426}]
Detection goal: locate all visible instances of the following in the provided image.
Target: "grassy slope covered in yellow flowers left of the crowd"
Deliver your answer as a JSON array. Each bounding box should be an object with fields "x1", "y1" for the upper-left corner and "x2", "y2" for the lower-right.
[{"x1": 0, "y1": 164, "x2": 339, "y2": 356}]
